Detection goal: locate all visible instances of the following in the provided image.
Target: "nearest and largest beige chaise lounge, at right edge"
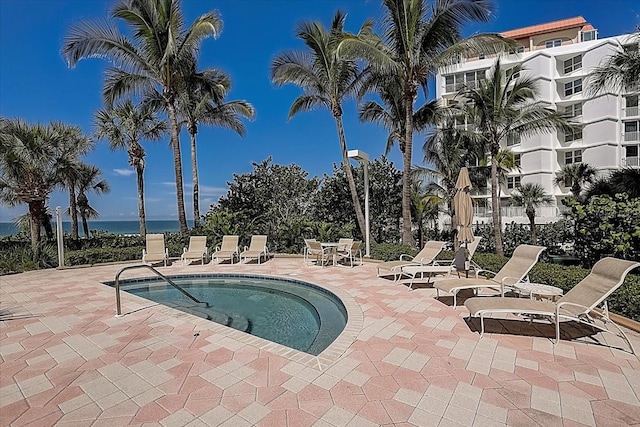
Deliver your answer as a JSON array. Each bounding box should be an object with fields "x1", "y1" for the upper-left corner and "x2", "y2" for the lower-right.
[{"x1": 464, "y1": 257, "x2": 640, "y2": 354}]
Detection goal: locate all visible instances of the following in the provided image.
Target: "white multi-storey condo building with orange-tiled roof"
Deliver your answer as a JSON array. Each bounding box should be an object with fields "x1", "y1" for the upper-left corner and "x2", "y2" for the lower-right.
[{"x1": 436, "y1": 17, "x2": 640, "y2": 224}]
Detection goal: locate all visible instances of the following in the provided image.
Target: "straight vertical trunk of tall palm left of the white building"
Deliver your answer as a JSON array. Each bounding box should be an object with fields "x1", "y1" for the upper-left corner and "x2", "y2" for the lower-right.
[{"x1": 402, "y1": 89, "x2": 415, "y2": 247}]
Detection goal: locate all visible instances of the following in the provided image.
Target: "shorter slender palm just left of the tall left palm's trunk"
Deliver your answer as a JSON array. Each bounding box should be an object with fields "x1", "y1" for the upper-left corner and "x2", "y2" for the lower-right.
[{"x1": 94, "y1": 99, "x2": 167, "y2": 237}]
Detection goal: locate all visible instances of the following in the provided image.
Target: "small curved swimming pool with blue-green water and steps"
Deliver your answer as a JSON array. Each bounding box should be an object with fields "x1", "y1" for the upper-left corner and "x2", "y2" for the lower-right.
[{"x1": 109, "y1": 274, "x2": 347, "y2": 355}]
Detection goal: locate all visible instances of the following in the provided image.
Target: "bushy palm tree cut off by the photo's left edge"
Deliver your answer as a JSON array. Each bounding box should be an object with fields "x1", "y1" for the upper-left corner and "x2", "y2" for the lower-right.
[{"x1": 0, "y1": 119, "x2": 62, "y2": 262}]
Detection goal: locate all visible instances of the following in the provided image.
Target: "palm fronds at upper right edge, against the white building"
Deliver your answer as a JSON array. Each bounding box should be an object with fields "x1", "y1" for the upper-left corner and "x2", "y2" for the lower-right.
[{"x1": 588, "y1": 32, "x2": 640, "y2": 95}]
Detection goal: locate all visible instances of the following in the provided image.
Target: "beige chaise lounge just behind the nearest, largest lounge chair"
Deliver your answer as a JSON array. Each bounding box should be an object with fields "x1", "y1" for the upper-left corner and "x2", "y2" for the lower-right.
[{"x1": 433, "y1": 245, "x2": 546, "y2": 308}]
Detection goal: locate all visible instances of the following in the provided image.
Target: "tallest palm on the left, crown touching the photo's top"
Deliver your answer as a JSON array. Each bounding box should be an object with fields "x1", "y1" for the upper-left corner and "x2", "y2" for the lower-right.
[{"x1": 62, "y1": 0, "x2": 222, "y2": 234}]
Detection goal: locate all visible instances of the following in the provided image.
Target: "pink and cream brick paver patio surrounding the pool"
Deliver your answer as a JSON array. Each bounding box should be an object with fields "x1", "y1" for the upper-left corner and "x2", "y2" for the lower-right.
[{"x1": 0, "y1": 258, "x2": 640, "y2": 427}]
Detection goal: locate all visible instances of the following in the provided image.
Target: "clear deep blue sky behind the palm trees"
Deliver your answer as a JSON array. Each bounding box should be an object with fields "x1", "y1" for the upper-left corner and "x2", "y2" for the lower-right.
[{"x1": 0, "y1": 0, "x2": 640, "y2": 222}]
